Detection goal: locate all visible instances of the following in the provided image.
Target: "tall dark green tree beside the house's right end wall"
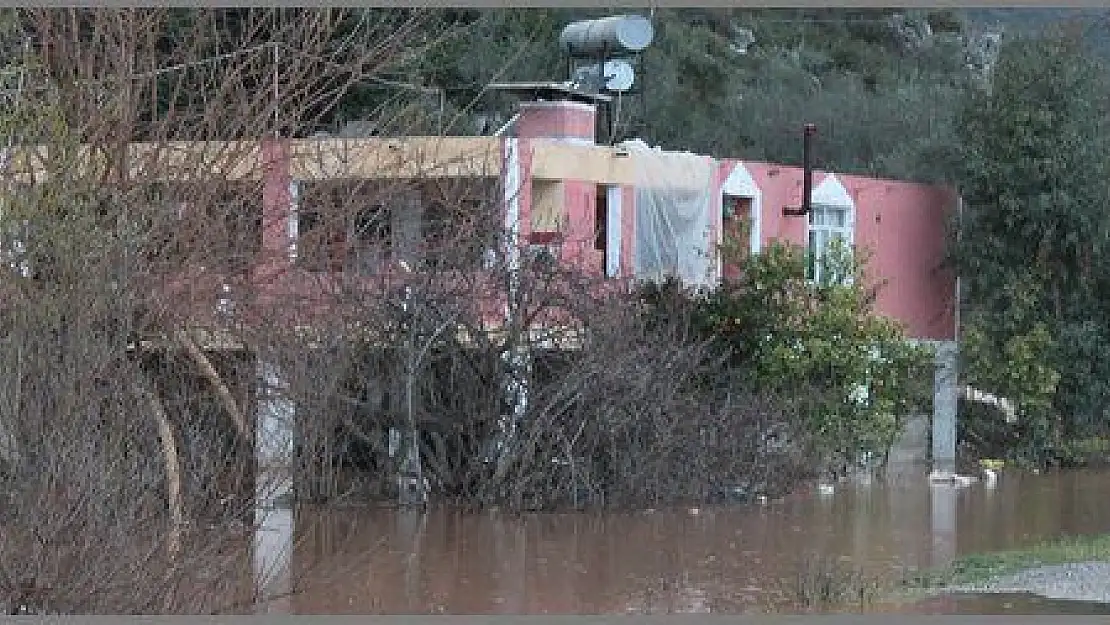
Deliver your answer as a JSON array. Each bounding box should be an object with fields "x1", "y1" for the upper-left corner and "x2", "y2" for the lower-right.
[{"x1": 955, "y1": 34, "x2": 1110, "y2": 462}]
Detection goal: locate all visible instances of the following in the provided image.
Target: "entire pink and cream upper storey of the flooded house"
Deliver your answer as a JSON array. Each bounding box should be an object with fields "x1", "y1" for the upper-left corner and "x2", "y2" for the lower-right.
[{"x1": 26, "y1": 93, "x2": 958, "y2": 341}]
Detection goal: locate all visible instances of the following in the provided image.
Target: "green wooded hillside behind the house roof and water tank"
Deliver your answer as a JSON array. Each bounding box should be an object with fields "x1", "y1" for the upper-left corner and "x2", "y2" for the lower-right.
[{"x1": 412, "y1": 9, "x2": 967, "y2": 179}]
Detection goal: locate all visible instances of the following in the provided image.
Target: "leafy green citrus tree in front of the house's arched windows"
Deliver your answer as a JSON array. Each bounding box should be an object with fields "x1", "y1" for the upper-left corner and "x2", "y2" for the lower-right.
[{"x1": 644, "y1": 238, "x2": 931, "y2": 475}]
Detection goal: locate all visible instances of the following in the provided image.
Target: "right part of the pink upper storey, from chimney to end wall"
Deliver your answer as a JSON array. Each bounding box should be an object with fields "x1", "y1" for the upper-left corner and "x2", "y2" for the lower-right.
[{"x1": 504, "y1": 95, "x2": 958, "y2": 341}]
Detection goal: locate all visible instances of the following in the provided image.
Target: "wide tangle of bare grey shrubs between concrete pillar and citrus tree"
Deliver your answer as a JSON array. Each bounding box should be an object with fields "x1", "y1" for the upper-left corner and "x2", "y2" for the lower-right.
[{"x1": 267, "y1": 204, "x2": 810, "y2": 508}]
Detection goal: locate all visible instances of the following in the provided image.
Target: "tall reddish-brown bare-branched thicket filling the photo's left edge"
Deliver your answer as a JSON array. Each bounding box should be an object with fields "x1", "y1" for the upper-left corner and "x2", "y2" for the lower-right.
[{"x1": 0, "y1": 9, "x2": 455, "y2": 613}]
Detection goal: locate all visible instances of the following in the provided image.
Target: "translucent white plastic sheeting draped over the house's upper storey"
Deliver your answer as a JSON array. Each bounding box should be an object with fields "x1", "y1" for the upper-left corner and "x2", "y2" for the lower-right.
[{"x1": 622, "y1": 140, "x2": 716, "y2": 285}]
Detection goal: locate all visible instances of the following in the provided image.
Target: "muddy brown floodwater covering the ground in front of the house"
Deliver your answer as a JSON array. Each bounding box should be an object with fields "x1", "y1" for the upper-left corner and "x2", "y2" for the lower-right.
[{"x1": 251, "y1": 472, "x2": 1110, "y2": 614}]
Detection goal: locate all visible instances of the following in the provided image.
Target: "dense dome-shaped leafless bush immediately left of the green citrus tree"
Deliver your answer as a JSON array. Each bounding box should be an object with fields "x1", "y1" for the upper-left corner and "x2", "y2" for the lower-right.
[{"x1": 468, "y1": 276, "x2": 805, "y2": 507}]
